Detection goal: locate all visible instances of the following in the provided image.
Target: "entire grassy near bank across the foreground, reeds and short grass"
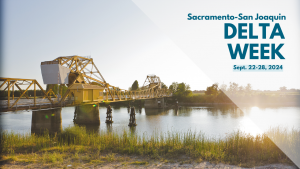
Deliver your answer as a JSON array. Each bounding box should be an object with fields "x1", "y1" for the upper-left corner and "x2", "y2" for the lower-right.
[{"x1": 1, "y1": 126, "x2": 300, "y2": 167}]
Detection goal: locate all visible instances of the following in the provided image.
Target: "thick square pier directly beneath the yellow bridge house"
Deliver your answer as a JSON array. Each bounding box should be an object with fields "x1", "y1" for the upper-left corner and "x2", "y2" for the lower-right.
[{"x1": 74, "y1": 104, "x2": 100, "y2": 125}]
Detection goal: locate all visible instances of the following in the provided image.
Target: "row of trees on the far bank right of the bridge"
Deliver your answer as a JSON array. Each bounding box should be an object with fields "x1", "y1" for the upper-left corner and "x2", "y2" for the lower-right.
[{"x1": 170, "y1": 82, "x2": 300, "y2": 105}]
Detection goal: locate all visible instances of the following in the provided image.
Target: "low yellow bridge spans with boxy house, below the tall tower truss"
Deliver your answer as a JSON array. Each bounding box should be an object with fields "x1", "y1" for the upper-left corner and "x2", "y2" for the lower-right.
[{"x1": 0, "y1": 78, "x2": 172, "y2": 112}]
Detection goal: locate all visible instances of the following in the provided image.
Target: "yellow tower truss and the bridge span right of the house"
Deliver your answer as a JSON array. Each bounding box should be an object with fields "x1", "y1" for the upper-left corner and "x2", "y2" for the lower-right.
[{"x1": 53, "y1": 56, "x2": 171, "y2": 102}]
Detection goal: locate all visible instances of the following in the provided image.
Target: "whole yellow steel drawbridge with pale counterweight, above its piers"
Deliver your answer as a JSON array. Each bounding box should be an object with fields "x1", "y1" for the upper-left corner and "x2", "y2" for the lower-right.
[{"x1": 0, "y1": 56, "x2": 172, "y2": 112}]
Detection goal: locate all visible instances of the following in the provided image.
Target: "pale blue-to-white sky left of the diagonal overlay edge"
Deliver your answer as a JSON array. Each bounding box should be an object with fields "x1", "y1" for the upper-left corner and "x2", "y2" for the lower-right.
[{"x1": 1, "y1": 0, "x2": 212, "y2": 90}]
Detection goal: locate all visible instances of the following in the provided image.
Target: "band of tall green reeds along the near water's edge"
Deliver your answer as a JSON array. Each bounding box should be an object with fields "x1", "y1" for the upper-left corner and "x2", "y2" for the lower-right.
[{"x1": 0, "y1": 126, "x2": 300, "y2": 164}]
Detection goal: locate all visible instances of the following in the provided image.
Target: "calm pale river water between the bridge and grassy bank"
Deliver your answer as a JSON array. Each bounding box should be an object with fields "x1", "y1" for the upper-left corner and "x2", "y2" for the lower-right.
[{"x1": 0, "y1": 106, "x2": 300, "y2": 137}]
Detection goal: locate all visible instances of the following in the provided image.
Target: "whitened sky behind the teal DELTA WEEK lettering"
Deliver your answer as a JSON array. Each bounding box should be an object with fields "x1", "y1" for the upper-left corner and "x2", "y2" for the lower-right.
[{"x1": 133, "y1": 0, "x2": 300, "y2": 90}]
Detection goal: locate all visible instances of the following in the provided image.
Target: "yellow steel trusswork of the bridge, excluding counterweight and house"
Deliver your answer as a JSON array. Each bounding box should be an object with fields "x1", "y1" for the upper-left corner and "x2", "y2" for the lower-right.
[{"x1": 0, "y1": 56, "x2": 172, "y2": 111}]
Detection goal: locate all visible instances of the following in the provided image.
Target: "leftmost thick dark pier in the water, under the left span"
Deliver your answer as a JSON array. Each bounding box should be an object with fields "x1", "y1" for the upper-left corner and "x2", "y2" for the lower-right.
[{"x1": 31, "y1": 108, "x2": 62, "y2": 134}]
